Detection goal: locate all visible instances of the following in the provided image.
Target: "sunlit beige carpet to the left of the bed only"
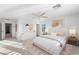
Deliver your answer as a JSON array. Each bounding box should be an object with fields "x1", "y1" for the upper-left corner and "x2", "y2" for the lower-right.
[{"x1": 0, "y1": 40, "x2": 48, "y2": 55}]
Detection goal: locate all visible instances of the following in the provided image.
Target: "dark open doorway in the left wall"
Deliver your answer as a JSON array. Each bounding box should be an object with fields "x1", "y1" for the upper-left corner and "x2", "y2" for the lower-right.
[{"x1": 5, "y1": 23, "x2": 12, "y2": 38}]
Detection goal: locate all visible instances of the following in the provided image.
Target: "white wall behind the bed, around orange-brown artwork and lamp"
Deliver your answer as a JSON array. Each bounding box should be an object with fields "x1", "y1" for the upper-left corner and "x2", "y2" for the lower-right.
[{"x1": 49, "y1": 15, "x2": 79, "y2": 37}]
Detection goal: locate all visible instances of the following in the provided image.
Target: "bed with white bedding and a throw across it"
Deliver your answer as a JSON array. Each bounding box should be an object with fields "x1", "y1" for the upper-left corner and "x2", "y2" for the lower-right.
[{"x1": 33, "y1": 35, "x2": 66, "y2": 55}]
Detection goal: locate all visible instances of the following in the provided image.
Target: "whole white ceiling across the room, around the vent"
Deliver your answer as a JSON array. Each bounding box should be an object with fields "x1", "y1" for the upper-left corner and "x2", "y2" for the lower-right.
[{"x1": 0, "y1": 4, "x2": 79, "y2": 17}]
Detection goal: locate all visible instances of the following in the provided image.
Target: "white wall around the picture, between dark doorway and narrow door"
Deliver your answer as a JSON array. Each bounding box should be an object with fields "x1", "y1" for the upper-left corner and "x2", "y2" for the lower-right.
[{"x1": 17, "y1": 17, "x2": 35, "y2": 40}]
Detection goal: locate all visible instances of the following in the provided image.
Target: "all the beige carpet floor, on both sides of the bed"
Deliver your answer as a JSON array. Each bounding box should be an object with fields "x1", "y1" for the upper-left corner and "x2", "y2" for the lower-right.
[{"x1": 0, "y1": 40, "x2": 79, "y2": 55}]
